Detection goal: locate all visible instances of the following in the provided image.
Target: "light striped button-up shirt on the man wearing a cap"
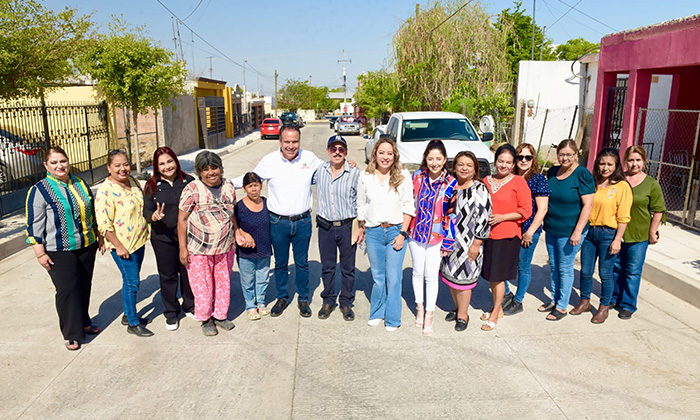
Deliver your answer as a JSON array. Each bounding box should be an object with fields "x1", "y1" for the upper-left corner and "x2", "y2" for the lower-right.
[{"x1": 313, "y1": 162, "x2": 360, "y2": 222}]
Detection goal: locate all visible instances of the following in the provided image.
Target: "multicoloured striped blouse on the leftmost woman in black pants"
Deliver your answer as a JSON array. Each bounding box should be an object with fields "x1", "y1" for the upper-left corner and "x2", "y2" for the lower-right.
[{"x1": 26, "y1": 174, "x2": 97, "y2": 251}]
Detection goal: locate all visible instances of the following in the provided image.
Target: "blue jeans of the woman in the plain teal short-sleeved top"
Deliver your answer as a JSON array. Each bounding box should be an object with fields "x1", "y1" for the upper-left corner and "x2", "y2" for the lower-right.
[{"x1": 544, "y1": 231, "x2": 587, "y2": 312}]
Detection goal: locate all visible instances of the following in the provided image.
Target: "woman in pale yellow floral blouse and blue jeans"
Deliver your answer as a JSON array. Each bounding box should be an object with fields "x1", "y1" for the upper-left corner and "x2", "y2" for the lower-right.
[{"x1": 95, "y1": 150, "x2": 153, "y2": 337}]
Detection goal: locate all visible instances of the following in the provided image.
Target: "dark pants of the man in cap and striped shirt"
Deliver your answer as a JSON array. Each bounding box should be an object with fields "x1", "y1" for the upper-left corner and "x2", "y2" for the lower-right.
[{"x1": 318, "y1": 223, "x2": 355, "y2": 306}]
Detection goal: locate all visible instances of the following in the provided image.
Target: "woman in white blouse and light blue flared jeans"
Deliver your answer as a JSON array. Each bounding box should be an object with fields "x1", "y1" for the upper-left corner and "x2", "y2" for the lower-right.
[{"x1": 357, "y1": 136, "x2": 415, "y2": 332}]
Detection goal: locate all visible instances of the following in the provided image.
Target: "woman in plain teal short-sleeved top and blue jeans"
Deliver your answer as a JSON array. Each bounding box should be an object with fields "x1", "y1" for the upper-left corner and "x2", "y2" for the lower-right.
[{"x1": 537, "y1": 139, "x2": 595, "y2": 321}]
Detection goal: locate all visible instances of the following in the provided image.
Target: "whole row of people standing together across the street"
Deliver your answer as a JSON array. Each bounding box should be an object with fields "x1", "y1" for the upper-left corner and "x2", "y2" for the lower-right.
[{"x1": 26, "y1": 126, "x2": 665, "y2": 350}]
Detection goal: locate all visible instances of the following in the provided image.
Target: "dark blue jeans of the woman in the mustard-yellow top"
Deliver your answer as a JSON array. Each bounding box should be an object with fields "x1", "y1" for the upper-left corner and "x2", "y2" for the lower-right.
[{"x1": 581, "y1": 226, "x2": 617, "y2": 306}]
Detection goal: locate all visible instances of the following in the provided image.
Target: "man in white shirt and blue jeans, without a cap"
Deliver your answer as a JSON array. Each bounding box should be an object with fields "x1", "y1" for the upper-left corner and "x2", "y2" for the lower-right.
[{"x1": 233, "y1": 125, "x2": 323, "y2": 318}]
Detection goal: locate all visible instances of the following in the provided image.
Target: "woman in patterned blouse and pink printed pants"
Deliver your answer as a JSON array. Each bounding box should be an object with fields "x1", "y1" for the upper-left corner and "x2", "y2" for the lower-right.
[{"x1": 177, "y1": 151, "x2": 238, "y2": 336}]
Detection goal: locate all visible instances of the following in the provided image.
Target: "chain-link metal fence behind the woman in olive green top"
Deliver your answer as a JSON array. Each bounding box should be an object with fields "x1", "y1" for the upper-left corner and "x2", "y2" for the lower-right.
[{"x1": 635, "y1": 108, "x2": 700, "y2": 230}]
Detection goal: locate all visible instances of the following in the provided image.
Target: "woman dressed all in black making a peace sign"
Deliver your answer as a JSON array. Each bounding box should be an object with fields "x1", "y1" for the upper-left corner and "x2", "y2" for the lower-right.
[{"x1": 143, "y1": 147, "x2": 194, "y2": 331}]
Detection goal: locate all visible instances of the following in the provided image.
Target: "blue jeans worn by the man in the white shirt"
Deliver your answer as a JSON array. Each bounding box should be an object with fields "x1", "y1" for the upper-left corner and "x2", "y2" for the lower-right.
[{"x1": 270, "y1": 213, "x2": 311, "y2": 302}]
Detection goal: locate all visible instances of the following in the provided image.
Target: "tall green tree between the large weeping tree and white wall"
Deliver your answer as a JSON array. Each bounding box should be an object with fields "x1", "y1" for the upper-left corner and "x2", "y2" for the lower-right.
[{"x1": 495, "y1": 1, "x2": 556, "y2": 81}]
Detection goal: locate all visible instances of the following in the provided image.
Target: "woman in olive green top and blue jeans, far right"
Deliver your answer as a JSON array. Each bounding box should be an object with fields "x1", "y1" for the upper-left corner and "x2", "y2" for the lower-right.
[{"x1": 611, "y1": 146, "x2": 666, "y2": 319}]
